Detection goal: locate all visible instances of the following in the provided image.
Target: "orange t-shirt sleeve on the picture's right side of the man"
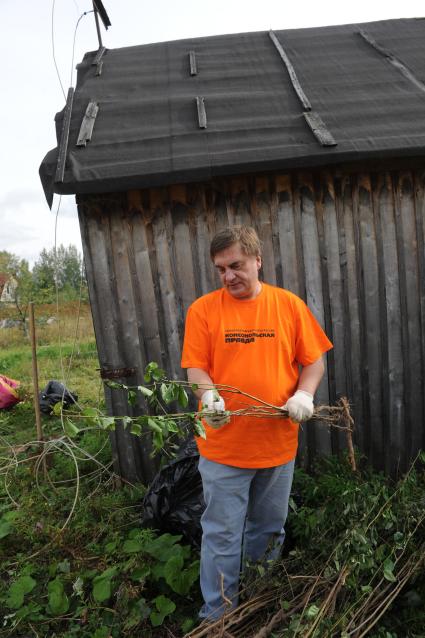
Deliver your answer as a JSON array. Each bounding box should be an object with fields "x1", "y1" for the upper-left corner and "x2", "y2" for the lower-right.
[{"x1": 294, "y1": 298, "x2": 333, "y2": 366}]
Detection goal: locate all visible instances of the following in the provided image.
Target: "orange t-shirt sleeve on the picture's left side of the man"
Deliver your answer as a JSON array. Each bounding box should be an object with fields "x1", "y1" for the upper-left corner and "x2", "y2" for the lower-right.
[{"x1": 181, "y1": 302, "x2": 211, "y2": 373}]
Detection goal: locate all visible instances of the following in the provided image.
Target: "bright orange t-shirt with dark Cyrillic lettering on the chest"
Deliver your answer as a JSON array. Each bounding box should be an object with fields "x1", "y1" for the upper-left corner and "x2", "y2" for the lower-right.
[{"x1": 181, "y1": 283, "x2": 332, "y2": 468}]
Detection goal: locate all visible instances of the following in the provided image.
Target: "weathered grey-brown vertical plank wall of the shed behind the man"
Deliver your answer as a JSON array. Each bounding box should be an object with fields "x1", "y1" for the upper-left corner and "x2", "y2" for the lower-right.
[{"x1": 78, "y1": 168, "x2": 425, "y2": 481}]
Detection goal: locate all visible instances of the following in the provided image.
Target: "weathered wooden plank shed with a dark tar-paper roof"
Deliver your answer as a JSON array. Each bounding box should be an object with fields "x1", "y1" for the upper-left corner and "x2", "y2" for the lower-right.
[{"x1": 40, "y1": 19, "x2": 425, "y2": 481}]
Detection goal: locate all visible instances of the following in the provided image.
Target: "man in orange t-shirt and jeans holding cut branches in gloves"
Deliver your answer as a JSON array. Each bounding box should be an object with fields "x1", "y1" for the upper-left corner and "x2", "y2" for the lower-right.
[{"x1": 181, "y1": 226, "x2": 332, "y2": 620}]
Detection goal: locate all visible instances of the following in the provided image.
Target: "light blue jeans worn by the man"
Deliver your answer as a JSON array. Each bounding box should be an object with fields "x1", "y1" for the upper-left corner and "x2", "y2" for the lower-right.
[{"x1": 199, "y1": 456, "x2": 294, "y2": 620}]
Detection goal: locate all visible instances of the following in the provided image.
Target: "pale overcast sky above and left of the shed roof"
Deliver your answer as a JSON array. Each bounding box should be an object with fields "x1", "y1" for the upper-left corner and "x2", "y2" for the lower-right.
[{"x1": 0, "y1": 0, "x2": 425, "y2": 264}]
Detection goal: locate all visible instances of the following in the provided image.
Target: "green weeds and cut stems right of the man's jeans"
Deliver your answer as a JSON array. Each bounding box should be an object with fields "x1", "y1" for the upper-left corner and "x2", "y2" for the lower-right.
[{"x1": 264, "y1": 457, "x2": 425, "y2": 638}]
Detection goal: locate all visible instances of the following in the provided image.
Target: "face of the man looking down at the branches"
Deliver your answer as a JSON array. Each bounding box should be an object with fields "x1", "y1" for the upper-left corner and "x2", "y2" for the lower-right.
[{"x1": 213, "y1": 242, "x2": 261, "y2": 299}]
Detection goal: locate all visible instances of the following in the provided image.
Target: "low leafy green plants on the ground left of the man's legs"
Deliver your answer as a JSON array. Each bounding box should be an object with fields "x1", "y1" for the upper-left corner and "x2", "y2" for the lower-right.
[{"x1": 0, "y1": 470, "x2": 200, "y2": 638}]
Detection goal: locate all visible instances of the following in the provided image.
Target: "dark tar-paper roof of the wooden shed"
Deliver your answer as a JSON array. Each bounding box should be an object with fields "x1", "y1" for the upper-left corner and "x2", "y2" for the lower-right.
[{"x1": 40, "y1": 18, "x2": 425, "y2": 201}]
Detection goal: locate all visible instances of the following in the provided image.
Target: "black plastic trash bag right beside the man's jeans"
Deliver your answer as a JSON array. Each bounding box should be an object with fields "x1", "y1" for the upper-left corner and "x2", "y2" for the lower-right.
[{"x1": 142, "y1": 439, "x2": 205, "y2": 549}]
